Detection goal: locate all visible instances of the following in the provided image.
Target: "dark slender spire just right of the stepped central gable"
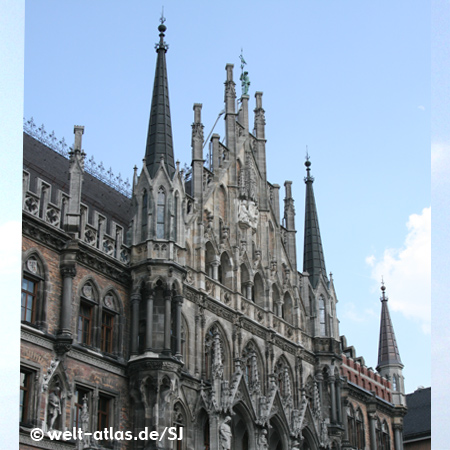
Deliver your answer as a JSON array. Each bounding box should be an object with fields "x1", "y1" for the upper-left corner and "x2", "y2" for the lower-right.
[{"x1": 303, "y1": 154, "x2": 327, "y2": 288}]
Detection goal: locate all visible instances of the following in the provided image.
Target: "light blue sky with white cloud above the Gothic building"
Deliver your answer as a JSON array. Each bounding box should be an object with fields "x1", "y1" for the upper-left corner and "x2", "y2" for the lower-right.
[{"x1": 0, "y1": 0, "x2": 432, "y2": 446}]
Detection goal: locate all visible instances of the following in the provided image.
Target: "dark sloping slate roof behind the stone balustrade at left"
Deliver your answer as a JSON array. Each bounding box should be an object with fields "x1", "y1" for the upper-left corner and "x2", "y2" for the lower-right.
[{"x1": 23, "y1": 133, "x2": 131, "y2": 233}]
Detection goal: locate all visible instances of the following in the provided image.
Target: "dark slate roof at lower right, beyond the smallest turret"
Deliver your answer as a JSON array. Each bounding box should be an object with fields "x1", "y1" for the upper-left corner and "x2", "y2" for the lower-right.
[{"x1": 403, "y1": 387, "x2": 431, "y2": 441}]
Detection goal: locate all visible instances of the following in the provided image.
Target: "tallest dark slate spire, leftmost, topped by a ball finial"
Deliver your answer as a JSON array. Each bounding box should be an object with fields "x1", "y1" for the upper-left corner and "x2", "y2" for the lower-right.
[{"x1": 145, "y1": 15, "x2": 175, "y2": 178}]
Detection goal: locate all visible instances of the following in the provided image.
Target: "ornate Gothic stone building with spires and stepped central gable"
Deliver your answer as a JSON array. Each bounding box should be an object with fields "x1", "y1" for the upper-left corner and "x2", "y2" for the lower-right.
[{"x1": 20, "y1": 22, "x2": 406, "y2": 450}]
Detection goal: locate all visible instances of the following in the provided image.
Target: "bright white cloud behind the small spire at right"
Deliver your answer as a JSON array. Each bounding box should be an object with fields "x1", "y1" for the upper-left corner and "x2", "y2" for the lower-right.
[{"x1": 366, "y1": 207, "x2": 431, "y2": 334}]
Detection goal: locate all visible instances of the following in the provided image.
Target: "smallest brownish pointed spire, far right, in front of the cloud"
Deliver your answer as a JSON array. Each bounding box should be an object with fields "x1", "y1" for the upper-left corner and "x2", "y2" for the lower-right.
[{"x1": 377, "y1": 281, "x2": 402, "y2": 371}]
